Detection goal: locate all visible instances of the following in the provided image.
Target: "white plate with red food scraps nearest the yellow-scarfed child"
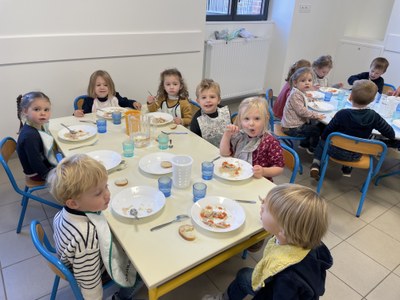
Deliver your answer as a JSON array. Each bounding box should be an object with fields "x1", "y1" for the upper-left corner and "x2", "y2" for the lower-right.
[{"x1": 190, "y1": 196, "x2": 246, "y2": 232}]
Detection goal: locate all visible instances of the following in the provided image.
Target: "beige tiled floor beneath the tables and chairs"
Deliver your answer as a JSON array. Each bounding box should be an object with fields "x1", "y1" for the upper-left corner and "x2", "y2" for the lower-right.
[{"x1": 0, "y1": 120, "x2": 400, "y2": 300}]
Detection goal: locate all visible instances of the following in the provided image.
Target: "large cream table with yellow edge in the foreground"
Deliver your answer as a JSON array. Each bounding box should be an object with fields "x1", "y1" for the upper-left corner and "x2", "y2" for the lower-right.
[{"x1": 49, "y1": 114, "x2": 274, "y2": 299}]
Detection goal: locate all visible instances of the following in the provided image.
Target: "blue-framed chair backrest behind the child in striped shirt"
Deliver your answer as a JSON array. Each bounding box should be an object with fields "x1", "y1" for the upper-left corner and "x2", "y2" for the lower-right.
[{"x1": 30, "y1": 220, "x2": 83, "y2": 299}]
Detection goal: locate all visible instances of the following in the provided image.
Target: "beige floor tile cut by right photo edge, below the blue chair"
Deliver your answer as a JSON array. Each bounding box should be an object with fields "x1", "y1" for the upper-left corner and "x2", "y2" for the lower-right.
[{"x1": 346, "y1": 225, "x2": 400, "y2": 270}]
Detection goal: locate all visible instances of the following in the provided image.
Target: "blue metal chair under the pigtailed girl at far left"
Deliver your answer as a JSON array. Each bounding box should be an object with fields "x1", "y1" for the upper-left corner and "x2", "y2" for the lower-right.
[{"x1": 0, "y1": 137, "x2": 62, "y2": 233}]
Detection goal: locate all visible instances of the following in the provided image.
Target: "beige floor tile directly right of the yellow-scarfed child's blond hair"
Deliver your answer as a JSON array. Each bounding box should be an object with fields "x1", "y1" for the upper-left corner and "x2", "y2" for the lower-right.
[{"x1": 328, "y1": 203, "x2": 367, "y2": 239}]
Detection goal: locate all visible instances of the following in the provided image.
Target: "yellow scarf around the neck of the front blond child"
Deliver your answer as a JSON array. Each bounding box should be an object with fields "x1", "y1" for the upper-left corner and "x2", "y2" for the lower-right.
[{"x1": 251, "y1": 236, "x2": 311, "y2": 291}]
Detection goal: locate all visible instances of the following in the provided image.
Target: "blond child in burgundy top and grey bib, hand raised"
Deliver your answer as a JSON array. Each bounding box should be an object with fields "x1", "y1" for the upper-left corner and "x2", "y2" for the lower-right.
[{"x1": 220, "y1": 97, "x2": 284, "y2": 181}]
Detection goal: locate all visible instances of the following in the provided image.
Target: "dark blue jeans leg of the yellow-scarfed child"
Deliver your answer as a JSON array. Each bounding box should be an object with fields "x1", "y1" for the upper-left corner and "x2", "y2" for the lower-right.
[{"x1": 228, "y1": 268, "x2": 255, "y2": 300}]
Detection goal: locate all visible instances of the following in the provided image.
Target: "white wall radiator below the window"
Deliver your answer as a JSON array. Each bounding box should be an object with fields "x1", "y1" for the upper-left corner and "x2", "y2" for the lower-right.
[{"x1": 203, "y1": 38, "x2": 268, "y2": 100}]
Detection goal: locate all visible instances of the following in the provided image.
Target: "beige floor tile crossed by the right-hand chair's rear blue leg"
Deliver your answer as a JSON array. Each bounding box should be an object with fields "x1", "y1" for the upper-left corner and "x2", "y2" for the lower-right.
[{"x1": 331, "y1": 189, "x2": 393, "y2": 222}]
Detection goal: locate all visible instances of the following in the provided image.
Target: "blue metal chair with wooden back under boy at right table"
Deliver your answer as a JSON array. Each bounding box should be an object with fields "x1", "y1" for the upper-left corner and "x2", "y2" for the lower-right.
[{"x1": 317, "y1": 132, "x2": 387, "y2": 217}]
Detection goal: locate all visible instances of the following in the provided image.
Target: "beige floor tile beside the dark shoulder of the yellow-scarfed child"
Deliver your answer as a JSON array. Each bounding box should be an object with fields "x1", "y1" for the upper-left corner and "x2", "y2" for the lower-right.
[{"x1": 330, "y1": 242, "x2": 390, "y2": 296}]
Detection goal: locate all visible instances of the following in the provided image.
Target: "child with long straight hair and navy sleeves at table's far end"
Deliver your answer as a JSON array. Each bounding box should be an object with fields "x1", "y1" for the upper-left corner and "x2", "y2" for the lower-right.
[{"x1": 74, "y1": 70, "x2": 142, "y2": 117}]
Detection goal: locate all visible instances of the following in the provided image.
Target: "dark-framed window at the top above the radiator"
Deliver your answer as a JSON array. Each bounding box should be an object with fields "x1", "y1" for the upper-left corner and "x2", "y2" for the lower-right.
[{"x1": 207, "y1": 0, "x2": 269, "y2": 21}]
